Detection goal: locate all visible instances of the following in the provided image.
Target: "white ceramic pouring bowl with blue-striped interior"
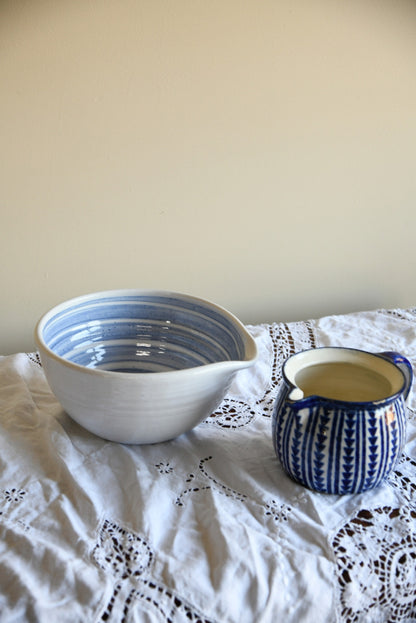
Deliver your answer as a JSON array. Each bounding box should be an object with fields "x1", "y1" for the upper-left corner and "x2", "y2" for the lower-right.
[{"x1": 35, "y1": 290, "x2": 257, "y2": 444}]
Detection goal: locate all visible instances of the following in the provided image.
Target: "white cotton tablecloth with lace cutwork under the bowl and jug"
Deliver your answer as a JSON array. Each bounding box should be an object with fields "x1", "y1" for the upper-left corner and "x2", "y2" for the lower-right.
[{"x1": 0, "y1": 309, "x2": 416, "y2": 623}]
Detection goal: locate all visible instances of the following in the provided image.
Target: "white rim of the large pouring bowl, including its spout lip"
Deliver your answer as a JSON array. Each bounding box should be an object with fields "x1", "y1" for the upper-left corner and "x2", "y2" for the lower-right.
[{"x1": 34, "y1": 288, "x2": 259, "y2": 379}]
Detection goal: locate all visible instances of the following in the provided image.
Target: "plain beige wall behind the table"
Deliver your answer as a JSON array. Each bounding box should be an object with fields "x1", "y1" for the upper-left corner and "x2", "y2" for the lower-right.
[{"x1": 0, "y1": 0, "x2": 416, "y2": 354}]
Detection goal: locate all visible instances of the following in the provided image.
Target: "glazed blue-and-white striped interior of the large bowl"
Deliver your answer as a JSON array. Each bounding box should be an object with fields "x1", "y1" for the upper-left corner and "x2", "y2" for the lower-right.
[{"x1": 38, "y1": 291, "x2": 245, "y2": 373}]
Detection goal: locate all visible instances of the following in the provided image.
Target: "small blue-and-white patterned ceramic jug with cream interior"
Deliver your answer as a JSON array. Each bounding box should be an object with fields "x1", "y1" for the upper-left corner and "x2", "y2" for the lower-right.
[{"x1": 273, "y1": 347, "x2": 413, "y2": 494}]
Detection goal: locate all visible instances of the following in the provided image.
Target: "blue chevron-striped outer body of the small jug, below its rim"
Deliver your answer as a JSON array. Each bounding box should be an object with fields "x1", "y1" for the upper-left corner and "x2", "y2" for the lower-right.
[{"x1": 273, "y1": 388, "x2": 406, "y2": 494}]
